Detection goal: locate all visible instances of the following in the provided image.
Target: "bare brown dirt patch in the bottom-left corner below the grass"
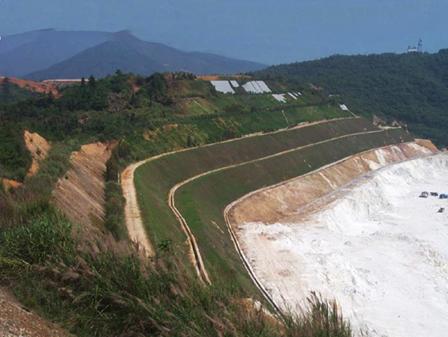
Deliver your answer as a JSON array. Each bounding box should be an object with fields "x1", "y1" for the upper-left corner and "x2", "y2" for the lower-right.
[{"x1": 0, "y1": 288, "x2": 69, "y2": 337}]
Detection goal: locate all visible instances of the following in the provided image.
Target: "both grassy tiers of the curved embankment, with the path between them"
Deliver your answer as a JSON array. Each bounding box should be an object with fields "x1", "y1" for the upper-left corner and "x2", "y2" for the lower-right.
[{"x1": 135, "y1": 118, "x2": 408, "y2": 289}]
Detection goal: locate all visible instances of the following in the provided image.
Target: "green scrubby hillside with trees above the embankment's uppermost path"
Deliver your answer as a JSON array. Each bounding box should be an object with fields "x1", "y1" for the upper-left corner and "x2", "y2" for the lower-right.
[{"x1": 0, "y1": 72, "x2": 347, "y2": 180}]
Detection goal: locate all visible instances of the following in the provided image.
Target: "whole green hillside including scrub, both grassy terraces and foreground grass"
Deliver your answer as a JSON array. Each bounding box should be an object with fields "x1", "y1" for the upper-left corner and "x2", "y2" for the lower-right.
[{"x1": 0, "y1": 72, "x2": 416, "y2": 337}]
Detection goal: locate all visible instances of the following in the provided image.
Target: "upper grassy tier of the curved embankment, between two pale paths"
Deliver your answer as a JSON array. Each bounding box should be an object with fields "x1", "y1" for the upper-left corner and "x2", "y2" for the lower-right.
[{"x1": 135, "y1": 118, "x2": 373, "y2": 245}]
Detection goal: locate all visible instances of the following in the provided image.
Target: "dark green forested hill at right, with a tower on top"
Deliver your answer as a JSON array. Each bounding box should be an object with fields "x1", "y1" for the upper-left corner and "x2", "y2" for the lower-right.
[{"x1": 257, "y1": 49, "x2": 448, "y2": 146}]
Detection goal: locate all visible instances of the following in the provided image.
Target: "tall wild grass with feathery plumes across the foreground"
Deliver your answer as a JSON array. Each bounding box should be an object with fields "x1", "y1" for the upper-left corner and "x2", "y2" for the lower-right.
[{"x1": 0, "y1": 209, "x2": 352, "y2": 337}]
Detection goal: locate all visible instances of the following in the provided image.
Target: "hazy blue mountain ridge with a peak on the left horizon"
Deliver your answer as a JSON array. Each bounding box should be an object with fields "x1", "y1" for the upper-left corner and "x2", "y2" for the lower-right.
[{"x1": 0, "y1": 29, "x2": 265, "y2": 80}]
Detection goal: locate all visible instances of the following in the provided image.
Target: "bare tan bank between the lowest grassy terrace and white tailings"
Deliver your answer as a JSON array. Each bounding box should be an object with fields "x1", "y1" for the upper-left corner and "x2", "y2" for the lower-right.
[{"x1": 228, "y1": 140, "x2": 438, "y2": 229}]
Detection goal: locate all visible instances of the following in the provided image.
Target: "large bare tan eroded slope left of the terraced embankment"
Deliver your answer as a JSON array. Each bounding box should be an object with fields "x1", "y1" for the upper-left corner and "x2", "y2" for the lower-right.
[{"x1": 53, "y1": 143, "x2": 114, "y2": 225}]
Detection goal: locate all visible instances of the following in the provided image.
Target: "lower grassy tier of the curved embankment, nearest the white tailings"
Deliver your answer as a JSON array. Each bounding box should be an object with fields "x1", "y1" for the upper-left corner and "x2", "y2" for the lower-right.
[{"x1": 176, "y1": 129, "x2": 411, "y2": 296}]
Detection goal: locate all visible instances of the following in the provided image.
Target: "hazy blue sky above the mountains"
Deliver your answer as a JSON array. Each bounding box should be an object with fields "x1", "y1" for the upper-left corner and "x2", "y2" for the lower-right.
[{"x1": 0, "y1": 0, "x2": 448, "y2": 63}]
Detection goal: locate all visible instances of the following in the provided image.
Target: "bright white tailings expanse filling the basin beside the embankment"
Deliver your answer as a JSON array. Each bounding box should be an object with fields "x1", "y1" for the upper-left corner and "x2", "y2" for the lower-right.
[{"x1": 238, "y1": 153, "x2": 448, "y2": 337}]
